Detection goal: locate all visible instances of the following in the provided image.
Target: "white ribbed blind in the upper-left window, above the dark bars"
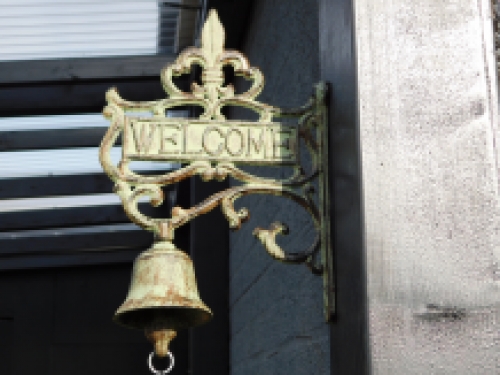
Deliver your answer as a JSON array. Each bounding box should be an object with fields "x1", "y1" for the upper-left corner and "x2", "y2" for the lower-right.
[{"x1": 0, "y1": 0, "x2": 186, "y2": 61}]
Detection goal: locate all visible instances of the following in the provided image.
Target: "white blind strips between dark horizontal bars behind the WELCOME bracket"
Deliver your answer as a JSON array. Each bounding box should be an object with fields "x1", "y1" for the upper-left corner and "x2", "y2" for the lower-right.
[{"x1": 0, "y1": 111, "x2": 180, "y2": 213}]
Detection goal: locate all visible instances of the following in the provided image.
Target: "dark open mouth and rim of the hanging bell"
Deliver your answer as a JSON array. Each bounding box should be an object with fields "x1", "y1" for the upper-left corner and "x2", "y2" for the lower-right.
[{"x1": 113, "y1": 307, "x2": 212, "y2": 331}]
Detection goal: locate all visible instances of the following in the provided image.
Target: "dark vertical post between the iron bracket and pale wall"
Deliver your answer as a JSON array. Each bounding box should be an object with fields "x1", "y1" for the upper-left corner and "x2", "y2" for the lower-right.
[{"x1": 319, "y1": 0, "x2": 370, "y2": 375}]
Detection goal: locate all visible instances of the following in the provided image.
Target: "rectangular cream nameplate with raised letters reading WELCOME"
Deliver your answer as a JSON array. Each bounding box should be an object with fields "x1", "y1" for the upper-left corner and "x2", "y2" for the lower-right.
[{"x1": 123, "y1": 118, "x2": 299, "y2": 165}]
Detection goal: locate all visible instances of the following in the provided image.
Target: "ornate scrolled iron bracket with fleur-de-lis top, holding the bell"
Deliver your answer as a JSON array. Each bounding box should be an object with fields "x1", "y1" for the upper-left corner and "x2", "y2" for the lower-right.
[{"x1": 100, "y1": 11, "x2": 334, "y2": 319}]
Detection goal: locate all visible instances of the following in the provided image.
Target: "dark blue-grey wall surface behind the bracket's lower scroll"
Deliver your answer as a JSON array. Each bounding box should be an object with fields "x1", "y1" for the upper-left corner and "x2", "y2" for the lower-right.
[{"x1": 230, "y1": 0, "x2": 330, "y2": 375}]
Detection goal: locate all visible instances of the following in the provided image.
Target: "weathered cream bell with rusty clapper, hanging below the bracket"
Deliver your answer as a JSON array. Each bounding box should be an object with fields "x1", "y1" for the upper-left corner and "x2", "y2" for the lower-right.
[{"x1": 113, "y1": 241, "x2": 212, "y2": 357}]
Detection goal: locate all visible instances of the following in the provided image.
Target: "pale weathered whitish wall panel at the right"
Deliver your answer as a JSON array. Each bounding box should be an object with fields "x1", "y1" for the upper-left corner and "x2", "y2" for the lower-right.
[{"x1": 356, "y1": 0, "x2": 500, "y2": 375}]
